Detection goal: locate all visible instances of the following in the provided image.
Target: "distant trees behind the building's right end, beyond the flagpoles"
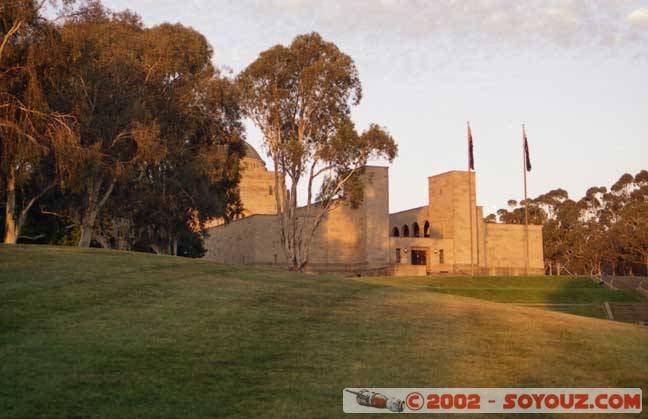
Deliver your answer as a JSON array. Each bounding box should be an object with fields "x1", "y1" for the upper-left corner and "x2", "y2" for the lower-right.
[{"x1": 486, "y1": 170, "x2": 648, "y2": 275}]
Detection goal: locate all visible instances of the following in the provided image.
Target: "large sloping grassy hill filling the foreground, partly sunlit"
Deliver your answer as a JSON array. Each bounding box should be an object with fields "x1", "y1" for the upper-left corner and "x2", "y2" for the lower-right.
[{"x1": 0, "y1": 246, "x2": 648, "y2": 418}]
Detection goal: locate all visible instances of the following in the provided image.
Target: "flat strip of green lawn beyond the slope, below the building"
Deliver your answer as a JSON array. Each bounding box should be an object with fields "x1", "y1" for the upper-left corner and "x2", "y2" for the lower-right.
[{"x1": 356, "y1": 276, "x2": 645, "y2": 318}]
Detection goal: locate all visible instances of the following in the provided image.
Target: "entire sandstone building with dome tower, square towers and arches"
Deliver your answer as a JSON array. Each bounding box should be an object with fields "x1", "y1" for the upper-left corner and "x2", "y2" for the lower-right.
[{"x1": 205, "y1": 143, "x2": 544, "y2": 275}]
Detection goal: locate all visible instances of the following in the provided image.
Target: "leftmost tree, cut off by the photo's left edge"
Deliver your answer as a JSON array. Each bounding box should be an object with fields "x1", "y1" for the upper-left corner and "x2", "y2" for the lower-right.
[{"x1": 0, "y1": 1, "x2": 76, "y2": 243}]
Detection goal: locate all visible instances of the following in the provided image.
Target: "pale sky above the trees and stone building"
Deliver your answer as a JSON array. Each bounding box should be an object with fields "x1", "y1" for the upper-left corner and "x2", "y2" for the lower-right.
[{"x1": 104, "y1": 0, "x2": 648, "y2": 214}]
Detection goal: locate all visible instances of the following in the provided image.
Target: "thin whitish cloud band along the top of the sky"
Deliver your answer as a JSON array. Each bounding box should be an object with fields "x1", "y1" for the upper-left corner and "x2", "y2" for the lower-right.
[{"x1": 254, "y1": 0, "x2": 648, "y2": 46}]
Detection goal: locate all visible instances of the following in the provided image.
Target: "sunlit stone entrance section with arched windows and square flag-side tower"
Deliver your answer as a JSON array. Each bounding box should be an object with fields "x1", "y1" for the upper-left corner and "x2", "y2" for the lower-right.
[{"x1": 389, "y1": 171, "x2": 544, "y2": 275}]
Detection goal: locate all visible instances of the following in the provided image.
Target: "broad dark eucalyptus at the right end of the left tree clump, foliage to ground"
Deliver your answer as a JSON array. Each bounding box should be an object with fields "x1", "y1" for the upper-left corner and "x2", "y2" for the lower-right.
[{"x1": 85, "y1": 24, "x2": 244, "y2": 254}]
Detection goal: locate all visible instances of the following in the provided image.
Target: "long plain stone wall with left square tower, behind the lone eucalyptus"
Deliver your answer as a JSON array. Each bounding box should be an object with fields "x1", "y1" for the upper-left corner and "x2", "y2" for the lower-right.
[{"x1": 205, "y1": 167, "x2": 389, "y2": 273}]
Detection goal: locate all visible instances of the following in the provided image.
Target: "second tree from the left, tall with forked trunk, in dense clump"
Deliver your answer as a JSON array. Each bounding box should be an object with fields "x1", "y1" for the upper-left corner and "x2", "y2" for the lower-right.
[{"x1": 58, "y1": 2, "x2": 163, "y2": 247}]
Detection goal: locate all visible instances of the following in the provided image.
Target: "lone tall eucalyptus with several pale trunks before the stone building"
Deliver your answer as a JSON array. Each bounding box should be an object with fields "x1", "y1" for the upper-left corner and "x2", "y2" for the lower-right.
[{"x1": 238, "y1": 33, "x2": 397, "y2": 271}]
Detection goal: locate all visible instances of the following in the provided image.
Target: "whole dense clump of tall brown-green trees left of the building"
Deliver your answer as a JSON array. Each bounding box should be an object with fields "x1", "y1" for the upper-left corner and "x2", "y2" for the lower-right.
[{"x1": 0, "y1": 0, "x2": 244, "y2": 256}]
